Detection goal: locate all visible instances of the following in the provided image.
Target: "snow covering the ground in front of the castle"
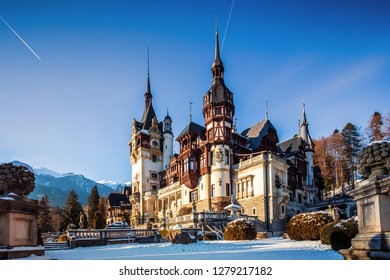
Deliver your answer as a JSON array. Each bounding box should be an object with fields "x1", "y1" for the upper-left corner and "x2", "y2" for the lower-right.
[{"x1": 45, "y1": 238, "x2": 343, "y2": 260}]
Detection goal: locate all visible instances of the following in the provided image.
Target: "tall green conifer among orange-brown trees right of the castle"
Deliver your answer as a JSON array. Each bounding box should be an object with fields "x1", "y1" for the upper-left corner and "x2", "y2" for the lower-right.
[{"x1": 341, "y1": 123, "x2": 361, "y2": 187}]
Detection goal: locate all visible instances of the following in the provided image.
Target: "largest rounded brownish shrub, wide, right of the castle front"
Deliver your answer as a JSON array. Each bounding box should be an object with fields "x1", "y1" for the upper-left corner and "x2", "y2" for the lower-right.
[{"x1": 287, "y1": 212, "x2": 333, "y2": 240}]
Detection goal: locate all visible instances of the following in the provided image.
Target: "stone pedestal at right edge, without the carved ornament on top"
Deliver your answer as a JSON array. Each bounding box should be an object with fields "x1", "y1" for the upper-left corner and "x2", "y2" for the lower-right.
[{"x1": 340, "y1": 175, "x2": 390, "y2": 260}]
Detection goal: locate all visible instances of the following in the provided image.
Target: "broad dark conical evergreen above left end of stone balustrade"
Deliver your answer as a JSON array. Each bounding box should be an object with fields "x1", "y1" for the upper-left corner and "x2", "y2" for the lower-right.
[{"x1": 60, "y1": 190, "x2": 86, "y2": 231}]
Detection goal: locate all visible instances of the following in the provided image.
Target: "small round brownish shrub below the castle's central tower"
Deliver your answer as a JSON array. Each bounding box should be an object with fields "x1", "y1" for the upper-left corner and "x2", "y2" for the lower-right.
[{"x1": 224, "y1": 219, "x2": 257, "y2": 240}]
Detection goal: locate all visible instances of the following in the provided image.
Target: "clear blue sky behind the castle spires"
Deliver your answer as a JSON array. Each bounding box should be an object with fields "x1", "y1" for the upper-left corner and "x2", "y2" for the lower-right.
[{"x1": 0, "y1": 0, "x2": 390, "y2": 182}]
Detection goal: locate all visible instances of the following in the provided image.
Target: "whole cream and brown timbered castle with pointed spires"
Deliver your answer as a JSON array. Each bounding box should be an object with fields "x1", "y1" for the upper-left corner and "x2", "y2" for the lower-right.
[{"x1": 129, "y1": 28, "x2": 323, "y2": 232}]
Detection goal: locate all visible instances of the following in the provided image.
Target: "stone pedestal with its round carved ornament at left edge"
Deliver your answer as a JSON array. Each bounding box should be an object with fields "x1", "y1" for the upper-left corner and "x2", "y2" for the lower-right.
[{"x1": 0, "y1": 163, "x2": 44, "y2": 259}]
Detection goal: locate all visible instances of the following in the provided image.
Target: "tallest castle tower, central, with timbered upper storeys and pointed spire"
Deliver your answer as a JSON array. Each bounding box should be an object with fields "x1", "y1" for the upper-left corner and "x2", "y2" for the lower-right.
[{"x1": 203, "y1": 24, "x2": 234, "y2": 208}]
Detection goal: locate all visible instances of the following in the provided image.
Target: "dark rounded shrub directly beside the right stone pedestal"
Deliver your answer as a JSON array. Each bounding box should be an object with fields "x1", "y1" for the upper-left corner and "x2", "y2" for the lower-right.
[{"x1": 321, "y1": 217, "x2": 358, "y2": 251}]
